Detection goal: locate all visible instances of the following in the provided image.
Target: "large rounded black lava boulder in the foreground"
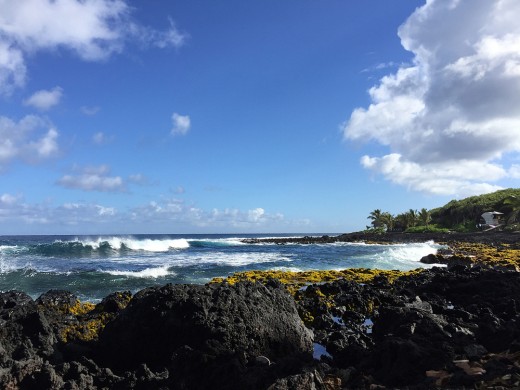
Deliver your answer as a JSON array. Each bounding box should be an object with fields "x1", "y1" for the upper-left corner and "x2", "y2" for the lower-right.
[{"x1": 100, "y1": 283, "x2": 312, "y2": 367}]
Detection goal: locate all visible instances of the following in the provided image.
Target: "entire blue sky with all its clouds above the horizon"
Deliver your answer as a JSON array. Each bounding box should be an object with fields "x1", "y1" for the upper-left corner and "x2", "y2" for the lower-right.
[{"x1": 0, "y1": 0, "x2": 520, "y2": 235}]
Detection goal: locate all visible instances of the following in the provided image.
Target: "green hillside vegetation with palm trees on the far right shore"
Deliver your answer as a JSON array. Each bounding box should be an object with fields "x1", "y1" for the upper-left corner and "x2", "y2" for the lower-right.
[{"x1": 367, "y1": 188, "x2": 520, "y2": 233}]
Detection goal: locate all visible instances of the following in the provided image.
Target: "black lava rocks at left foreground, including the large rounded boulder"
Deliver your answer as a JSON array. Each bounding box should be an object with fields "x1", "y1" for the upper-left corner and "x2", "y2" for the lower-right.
[{"x1": 0, "y1": 281, "x2": 312, "y2": 389}]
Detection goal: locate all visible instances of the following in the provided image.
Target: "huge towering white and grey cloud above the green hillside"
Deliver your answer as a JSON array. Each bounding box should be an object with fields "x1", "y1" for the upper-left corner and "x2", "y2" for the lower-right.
[{"x1": 343, "y1": 0, "x2": 520, "y2": 195}]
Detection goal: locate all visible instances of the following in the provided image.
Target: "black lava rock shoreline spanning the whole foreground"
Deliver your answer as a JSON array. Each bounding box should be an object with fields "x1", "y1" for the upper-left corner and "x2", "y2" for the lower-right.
[{"x1": 0, "y1": 233, "x2": 520, "y2": 390}]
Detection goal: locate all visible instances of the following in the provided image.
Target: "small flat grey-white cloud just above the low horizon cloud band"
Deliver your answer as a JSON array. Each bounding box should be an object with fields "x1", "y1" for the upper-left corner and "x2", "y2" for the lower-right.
[{"x1": 56, "y1": 165, "x2": 126, "y2": 192}]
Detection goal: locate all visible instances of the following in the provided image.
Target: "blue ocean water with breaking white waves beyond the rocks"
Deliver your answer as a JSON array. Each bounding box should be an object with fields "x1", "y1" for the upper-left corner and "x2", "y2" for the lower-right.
[{"x1": 0, "y1": 234, "x2": 441, "y2": 302}]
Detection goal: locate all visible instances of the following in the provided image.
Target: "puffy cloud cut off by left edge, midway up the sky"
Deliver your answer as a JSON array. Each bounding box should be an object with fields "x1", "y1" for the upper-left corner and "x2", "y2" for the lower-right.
[{"x1": 0, "y1": 115, "x2": 59, "y2": 171}]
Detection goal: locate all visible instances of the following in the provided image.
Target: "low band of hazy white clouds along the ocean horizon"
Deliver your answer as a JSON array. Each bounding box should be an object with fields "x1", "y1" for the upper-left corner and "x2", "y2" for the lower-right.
[{"x1": 0, "y1": 190, "x2": 309, "y2": 234}]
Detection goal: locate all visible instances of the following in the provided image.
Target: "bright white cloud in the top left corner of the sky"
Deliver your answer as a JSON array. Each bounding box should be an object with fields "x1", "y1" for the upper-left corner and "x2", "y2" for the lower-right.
[{"x1": 0, "y1": 0, "x2": 186, "y2": 94}]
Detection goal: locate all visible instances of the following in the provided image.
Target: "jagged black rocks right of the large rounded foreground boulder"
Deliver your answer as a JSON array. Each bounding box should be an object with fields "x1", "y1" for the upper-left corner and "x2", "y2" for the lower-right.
[{"x1": 296, "y1": 266, "x2": 520, "y2": 388}]
